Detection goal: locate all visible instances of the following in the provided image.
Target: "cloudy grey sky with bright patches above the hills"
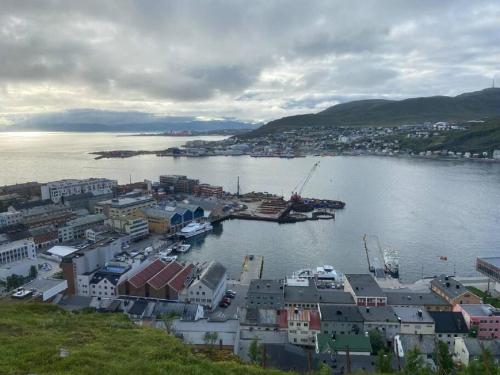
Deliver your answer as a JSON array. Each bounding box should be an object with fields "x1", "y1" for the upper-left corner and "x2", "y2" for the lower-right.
[{"x1": 0, "y1": 0, "x2": 500, "y2": 124}]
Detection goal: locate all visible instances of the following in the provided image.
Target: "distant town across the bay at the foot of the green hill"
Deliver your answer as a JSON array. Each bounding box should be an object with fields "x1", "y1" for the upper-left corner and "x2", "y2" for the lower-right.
[{"x1": 93, "y1": 121, "x2": 500, "y2": 161}]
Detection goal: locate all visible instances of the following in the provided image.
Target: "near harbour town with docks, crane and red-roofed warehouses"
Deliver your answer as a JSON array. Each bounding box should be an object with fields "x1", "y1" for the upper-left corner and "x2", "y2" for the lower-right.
[{"x1": 0, "y1": 176, "x2": 500, "y2": 374}]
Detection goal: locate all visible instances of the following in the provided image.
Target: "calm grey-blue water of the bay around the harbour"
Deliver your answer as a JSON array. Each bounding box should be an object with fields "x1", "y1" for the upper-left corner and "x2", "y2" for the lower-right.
[{"x1": 0, "y1": 133, "x2": 500, "y2": 281}]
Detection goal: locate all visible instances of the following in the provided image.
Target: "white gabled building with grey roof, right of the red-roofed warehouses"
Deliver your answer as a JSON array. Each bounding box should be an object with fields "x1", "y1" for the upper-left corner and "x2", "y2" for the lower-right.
[{"x1": 179, "y1": 261, "x2": 227, "y2": 310}]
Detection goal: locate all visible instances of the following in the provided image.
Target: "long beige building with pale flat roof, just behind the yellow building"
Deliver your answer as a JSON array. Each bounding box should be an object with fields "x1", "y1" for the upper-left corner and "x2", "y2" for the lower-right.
[{"x1": 95, "y1": 195, "x2": 156, "y2": 219}]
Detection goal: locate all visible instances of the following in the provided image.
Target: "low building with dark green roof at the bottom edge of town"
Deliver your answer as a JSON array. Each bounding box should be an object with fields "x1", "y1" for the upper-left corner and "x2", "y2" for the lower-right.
[{"x1": 316, "y1": 334, "x2": 372, "y2": 356}]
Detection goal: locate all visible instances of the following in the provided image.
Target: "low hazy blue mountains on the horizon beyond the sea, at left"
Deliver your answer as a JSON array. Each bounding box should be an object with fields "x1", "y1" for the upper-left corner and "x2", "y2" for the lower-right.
[{"x1": 1, "y1": 109, "x2": 258, "y2": 132}]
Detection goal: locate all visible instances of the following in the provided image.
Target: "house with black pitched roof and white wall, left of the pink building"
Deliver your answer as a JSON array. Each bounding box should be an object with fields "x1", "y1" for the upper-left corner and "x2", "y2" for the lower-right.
[{"x1": 429, "y1": 311, "x2": 469, "y2": 353}]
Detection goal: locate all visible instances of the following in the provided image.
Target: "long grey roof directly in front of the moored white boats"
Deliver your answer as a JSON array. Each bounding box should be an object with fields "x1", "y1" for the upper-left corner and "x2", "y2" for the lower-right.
[{"x1": 285, "y1": 283, "x2": 354, "y2": 305}]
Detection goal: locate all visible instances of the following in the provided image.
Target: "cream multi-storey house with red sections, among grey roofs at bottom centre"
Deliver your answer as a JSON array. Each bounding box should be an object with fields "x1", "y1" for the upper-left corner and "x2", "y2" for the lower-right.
[{"x1": 280, "y1": 307, "x2": 321, "y2": 347}]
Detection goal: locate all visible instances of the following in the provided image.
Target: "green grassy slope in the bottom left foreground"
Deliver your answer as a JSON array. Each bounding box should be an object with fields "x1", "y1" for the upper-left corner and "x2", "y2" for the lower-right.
[{"x1": 0, "y1": 302, "x2": 281, "y2": 375}]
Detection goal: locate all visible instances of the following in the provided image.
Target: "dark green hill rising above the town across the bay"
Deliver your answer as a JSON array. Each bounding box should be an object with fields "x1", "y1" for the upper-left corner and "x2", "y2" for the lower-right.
[{"x1": 247, "y1": 88, "x2": 500, "y2": 137}]
